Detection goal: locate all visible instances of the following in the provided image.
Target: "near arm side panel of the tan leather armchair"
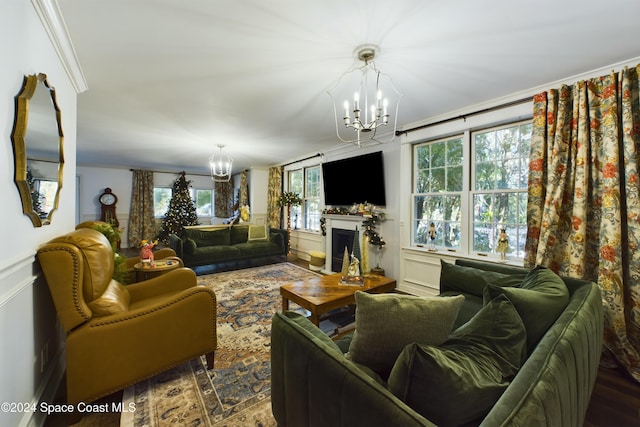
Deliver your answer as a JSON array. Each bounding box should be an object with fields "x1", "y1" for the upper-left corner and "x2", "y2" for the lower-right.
[{"x1": 67, "y1": 286, "x2": 217, "y2": 403}]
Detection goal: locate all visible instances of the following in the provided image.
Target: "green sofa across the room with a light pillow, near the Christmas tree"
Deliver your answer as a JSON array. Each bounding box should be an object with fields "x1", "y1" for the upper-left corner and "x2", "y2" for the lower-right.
[{"x1": 169, "y1": 224, "x2": 288, "y2": 267}]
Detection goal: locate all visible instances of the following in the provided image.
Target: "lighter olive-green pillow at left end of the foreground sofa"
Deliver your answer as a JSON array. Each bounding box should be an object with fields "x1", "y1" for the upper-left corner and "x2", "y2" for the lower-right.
[{"x1": 348, "y1": 291, "x2": 464, "y2": 379}]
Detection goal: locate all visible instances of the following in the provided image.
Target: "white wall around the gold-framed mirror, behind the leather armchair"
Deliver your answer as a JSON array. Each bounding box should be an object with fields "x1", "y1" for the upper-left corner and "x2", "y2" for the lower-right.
[{"x1": 0, "y1": 0, "x2": 77, "y2": 426}]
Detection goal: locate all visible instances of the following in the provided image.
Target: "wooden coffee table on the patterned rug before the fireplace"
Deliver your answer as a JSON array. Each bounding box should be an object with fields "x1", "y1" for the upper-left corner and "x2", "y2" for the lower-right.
[{"x1": 280, "y1": 273, "x2": 396, "y2": 326}]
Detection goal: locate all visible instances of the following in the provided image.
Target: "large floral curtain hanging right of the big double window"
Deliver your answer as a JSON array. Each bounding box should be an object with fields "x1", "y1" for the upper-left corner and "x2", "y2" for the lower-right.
[{"x1": 525, "y1": 65, "x2": 640, "y2": 381}]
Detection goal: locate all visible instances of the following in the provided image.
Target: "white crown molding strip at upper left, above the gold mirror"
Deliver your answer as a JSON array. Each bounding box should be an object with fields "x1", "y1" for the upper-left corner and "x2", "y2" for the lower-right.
[{"x1": 31, "y1": 0, "x2": 88, "y2": 93}]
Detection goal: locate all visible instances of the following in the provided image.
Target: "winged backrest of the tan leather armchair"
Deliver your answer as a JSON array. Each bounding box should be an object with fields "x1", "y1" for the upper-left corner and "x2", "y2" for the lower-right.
[{"x1": 38, "y1": 228, "x2": 114, "y2": 332}]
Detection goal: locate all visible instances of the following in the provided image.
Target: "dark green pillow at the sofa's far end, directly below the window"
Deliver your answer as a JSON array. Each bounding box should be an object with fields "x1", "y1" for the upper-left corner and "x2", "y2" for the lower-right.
[{"x1": 440, "y1": 260, "x2": 526, "y2": 297}]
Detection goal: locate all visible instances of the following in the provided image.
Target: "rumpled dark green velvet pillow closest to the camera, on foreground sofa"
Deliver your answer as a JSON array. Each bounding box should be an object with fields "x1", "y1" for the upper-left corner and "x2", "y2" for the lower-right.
[{"x1": 388, "y1": 297, "x2": 526, "y2": 425}]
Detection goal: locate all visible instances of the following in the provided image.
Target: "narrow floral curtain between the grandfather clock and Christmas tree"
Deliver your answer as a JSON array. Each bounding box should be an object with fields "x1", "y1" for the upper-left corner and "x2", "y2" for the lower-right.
[{"x1": 127, "y1": 170, "x2": 157, "y2": 248}]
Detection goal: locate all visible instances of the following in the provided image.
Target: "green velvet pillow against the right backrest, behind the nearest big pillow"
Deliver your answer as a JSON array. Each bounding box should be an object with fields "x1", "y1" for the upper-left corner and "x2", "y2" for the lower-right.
[{"x1": 484, "y1": 266, "x2": 569, "y2": 350}]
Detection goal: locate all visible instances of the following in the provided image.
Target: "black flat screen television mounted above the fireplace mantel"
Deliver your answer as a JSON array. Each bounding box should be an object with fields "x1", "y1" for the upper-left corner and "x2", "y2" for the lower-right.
[{"x1": 322, "y1": 151, "x2": 387, "y2": 206}]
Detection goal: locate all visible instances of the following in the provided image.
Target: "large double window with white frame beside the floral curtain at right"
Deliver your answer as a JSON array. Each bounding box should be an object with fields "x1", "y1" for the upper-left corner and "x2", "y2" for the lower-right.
[{"x1": 411, "y1": 121, "x2": 531, "y2": 258}]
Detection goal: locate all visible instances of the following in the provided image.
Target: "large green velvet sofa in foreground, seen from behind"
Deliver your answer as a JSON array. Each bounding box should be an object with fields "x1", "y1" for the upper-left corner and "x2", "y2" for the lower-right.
[{"x1": 271, "y1": 260, "x2": 603, "y2": 427}]
